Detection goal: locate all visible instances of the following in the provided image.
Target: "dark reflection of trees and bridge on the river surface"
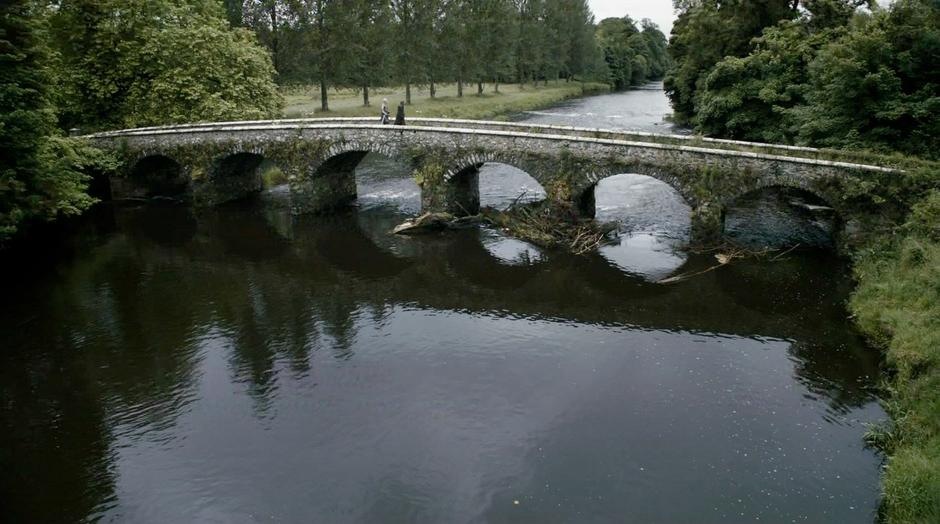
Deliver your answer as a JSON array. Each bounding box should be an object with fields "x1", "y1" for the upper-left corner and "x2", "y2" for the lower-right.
[{"x1": 0, "y1": 200, "x2": 877, "y2": 520}]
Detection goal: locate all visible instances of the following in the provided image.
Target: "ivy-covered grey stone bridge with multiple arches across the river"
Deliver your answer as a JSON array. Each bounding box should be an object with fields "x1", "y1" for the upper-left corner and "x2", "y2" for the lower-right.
[{"x1": 89, "y1": 118, "x2": 899, "y2": 241}]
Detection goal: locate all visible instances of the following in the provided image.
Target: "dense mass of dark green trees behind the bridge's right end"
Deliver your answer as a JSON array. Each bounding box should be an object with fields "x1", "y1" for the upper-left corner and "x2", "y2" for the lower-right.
[{"x1": 666, "y1": 0, "x2": 940, "y2": 158}]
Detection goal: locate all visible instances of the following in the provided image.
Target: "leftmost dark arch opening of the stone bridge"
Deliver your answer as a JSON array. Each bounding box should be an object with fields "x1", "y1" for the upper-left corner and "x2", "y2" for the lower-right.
[{"x1": 111, "y1": 153, "x2": 192, "y2": 200}]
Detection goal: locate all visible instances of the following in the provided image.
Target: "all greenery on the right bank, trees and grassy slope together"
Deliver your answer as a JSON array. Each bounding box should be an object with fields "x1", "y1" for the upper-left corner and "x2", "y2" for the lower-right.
[{"x1": 665, "y1": 0, "x2": 940, "y2": 523}]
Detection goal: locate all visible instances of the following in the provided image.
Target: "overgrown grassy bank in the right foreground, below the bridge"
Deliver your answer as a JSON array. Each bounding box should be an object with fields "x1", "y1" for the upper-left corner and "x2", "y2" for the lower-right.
[{"x1": 850, "y1": 190, "x2": 940, "y2": 523}]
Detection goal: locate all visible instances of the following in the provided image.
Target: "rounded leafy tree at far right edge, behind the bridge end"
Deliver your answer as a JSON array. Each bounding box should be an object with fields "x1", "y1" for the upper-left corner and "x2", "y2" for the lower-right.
[{"x1": 794, "y1": 0, "x2": 940, "y2": 158}]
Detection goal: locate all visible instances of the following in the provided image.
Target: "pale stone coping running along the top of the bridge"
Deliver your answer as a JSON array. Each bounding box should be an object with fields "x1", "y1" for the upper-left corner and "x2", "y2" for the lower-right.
[{"x1": 86, "y1": 119, "x2": 903, "y2": 174}]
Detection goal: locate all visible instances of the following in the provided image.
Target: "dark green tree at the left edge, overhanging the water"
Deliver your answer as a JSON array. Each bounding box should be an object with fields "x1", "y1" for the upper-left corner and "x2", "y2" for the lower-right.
[{"x1": 0, "y1": 0, "x2": 103, "y2": 243}]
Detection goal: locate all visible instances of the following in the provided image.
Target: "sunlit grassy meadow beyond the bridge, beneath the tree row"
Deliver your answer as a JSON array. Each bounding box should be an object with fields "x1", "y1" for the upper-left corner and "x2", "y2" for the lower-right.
[{"x1": 284, "y1": 81, "x2": 609, "y2": 121}]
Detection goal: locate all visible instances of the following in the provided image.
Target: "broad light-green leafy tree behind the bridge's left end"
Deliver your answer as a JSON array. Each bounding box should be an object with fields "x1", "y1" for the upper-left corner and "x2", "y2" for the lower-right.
[{"x1": 52, "y1": 0, "x2": 281, "y2": 128}]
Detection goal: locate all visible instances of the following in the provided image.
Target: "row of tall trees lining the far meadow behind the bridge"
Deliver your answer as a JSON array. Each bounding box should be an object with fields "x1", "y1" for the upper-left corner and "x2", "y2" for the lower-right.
[{"x1": 225, "y1": 0, "x2": 669, "y2": 109}]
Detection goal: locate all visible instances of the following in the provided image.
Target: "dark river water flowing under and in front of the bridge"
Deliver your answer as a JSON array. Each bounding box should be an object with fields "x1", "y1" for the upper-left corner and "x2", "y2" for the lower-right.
[{"x1": 0, "y1": 88, "x2": 884, "y2": 523}]
